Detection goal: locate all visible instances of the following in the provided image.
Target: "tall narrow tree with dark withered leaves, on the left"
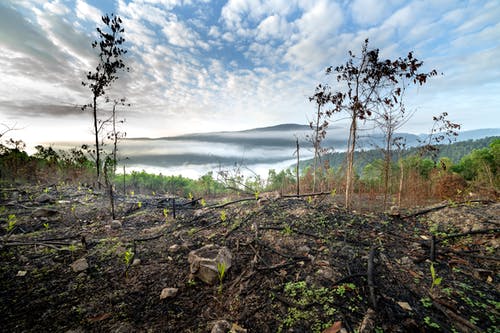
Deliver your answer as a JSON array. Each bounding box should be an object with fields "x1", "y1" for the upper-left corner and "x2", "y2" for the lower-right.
[{"x1": 82, "y1": 14, "x2": 129, "y2": 188}]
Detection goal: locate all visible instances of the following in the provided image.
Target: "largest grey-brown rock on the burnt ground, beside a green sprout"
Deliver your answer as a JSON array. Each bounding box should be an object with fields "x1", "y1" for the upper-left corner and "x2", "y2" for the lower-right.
[{"x1": 188, "y1": 244, "x2": 232, "y2": 284}]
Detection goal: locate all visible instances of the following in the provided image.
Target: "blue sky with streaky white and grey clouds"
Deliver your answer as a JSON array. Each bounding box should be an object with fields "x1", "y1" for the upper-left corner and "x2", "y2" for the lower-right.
[{"x1": 0, "y1": 0, "x2": 500, "y2": 148}]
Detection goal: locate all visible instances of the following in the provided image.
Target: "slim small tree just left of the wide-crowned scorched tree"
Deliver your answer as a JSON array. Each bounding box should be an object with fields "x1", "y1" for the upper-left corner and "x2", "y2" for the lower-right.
[{"x1": 307, "y1": 84, "x2": 332, "y2": 192}]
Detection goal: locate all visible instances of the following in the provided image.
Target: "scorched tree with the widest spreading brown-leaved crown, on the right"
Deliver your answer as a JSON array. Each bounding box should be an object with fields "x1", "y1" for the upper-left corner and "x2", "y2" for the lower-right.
[{"x1": 326, "y1": 39, "x2": 437, "y2": 208}]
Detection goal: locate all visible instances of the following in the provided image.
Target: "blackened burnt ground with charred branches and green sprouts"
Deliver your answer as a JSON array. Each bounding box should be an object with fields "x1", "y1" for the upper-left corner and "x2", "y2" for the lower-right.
[{"x1": 0, "y1": 186, "x2": 500, "y2": 333}]
